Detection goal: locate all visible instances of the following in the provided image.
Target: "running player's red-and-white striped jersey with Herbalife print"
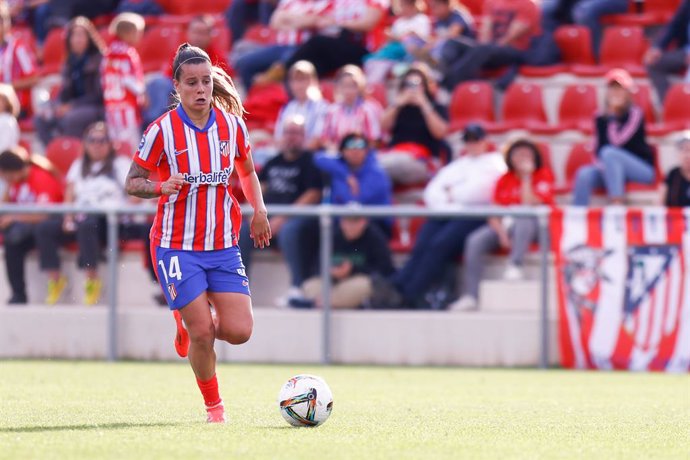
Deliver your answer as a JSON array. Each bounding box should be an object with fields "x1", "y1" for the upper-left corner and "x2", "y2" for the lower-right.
[{"x1": 134, "y1": 106, "x2": 250, "y2": 251}]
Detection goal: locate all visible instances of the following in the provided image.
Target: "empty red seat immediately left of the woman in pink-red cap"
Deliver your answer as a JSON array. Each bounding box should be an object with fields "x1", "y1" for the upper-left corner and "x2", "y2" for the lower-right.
[{"x1": 533, "y1": 85, "x2": 597, "y2": 134}]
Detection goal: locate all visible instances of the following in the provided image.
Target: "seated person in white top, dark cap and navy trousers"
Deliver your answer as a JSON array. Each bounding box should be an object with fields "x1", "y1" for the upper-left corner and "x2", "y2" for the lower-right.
[{"x1": 391, "y1": 124, "x2": 506, "y2": 307}]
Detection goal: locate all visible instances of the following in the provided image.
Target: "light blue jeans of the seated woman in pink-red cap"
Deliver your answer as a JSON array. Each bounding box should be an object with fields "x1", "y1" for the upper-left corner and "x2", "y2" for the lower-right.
[{"x1": 573, "y1": 145, "x2": 654, "y2": 206}]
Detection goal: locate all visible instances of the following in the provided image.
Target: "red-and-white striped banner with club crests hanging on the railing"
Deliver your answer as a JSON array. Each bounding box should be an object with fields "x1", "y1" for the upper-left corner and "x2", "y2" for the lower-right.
[{"x1": 551, "y1": 207, "x2": 690, "y2": 372}]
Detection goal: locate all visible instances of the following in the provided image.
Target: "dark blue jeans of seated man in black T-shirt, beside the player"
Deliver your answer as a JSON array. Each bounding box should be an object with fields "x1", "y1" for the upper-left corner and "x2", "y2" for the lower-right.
[{"x1": 239, "y1": 217, "x2": 319, "y2": 287}]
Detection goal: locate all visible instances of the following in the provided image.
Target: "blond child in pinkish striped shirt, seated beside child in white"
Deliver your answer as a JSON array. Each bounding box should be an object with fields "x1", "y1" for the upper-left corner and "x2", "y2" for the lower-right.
[{"x1": 321, "y1": 64, "x2": 383, "y2": 150}]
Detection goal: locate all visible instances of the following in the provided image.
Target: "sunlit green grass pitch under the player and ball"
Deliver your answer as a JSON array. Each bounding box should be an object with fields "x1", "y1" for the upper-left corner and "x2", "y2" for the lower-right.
[{"x1": 0, "y1": 361, "x2": 690, "y2": 460}]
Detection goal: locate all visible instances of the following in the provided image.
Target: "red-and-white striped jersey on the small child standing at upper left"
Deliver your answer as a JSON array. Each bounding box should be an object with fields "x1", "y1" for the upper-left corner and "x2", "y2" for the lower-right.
[{"x1": 101, "y1": 40, "x2": 146, "y2": 110}]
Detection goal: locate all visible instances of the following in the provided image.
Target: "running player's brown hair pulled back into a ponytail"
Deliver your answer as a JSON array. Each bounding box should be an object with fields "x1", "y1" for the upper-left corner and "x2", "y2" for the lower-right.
[{"x1": 173, "y1": 43, "x2": 244, "y2": 117}]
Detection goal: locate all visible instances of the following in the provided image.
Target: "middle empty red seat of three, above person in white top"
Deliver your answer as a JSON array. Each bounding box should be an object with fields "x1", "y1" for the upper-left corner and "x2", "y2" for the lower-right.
[{"x1": 487, "y1": 82, "x2": 547, "y2": 133}]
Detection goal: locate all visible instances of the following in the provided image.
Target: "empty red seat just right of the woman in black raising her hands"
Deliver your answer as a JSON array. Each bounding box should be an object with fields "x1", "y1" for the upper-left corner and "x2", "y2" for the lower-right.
[{"x1": 449, "y1": 81, "x2": 495, "y2": 132}]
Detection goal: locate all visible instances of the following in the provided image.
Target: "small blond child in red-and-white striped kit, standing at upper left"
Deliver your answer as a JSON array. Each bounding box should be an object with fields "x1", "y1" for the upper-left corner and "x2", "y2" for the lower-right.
[{"x1": 101, "y1": 13, "x2": 146, "y2": 154}]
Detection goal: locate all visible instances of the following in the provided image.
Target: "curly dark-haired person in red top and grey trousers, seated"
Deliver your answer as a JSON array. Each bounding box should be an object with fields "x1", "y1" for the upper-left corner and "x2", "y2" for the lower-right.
[{"x1": 449, "y1": 135, "x2": 554, "y2": 311}]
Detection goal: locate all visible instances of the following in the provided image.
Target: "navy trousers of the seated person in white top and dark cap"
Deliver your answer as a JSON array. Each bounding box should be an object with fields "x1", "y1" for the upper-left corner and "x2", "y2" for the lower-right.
[{"x1": 391, "y1": 219, "x2": 486, "y2": 302}]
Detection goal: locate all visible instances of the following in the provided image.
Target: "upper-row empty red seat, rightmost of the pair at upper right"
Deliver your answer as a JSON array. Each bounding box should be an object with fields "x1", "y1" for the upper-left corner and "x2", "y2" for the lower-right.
[{"x1": 572, "y1": 26, "x2": 649, "y2": 77}]
